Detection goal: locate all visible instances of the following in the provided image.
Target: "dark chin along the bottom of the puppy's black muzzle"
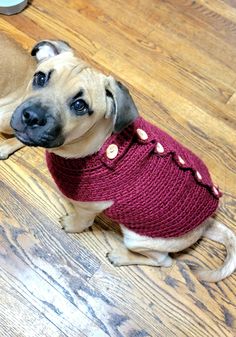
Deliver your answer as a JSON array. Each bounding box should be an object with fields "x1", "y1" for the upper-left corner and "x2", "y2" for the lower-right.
[{"x1": 15, "y1": 131, "x2": 64, "y2": 149}]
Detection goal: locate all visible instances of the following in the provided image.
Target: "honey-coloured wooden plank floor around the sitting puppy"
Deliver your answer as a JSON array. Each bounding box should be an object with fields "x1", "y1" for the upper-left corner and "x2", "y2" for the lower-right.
[{"x1": 0, "y1": 0, "x2": 236, "y2": 337}]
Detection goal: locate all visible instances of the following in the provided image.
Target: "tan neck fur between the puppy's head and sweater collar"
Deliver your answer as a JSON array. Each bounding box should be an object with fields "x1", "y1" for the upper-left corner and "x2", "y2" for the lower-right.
[{"x1": 48, "y1": 119, "x2": 113, "y2": 158}]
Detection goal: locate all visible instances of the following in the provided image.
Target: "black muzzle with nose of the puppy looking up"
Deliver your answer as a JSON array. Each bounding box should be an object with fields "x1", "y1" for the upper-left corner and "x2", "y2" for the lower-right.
[{"x1": 11, "y1": 99, "x2": 64, "y2": 148}]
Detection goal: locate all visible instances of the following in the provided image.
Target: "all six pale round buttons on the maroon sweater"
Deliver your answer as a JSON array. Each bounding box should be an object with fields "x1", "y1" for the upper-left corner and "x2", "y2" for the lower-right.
[{"x1": 106, "y1": 129, "x2": 219, "y2": 197}]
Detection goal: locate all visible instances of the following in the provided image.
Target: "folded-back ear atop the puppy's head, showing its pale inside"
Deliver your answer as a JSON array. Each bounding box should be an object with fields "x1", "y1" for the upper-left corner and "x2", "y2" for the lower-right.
[{"x1": 31, "y1": 40, "x2": 72, "y2": 62}]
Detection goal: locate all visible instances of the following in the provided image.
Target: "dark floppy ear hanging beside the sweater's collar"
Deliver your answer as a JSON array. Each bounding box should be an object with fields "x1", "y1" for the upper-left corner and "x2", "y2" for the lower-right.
[{"x1": 105, "y1": 76, "x2": 138, "y2": 132}]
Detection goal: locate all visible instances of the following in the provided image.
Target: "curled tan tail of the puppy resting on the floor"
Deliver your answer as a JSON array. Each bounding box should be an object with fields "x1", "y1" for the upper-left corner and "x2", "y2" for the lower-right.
[{"x1": 195, "y1": 220, "x2": 236, "y2": 282}]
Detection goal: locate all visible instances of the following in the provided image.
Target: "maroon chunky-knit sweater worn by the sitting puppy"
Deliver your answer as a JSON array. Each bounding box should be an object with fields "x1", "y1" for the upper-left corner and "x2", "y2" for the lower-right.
[{"x1": 46, "y1": 117, "x2": 221, "y2": 238}]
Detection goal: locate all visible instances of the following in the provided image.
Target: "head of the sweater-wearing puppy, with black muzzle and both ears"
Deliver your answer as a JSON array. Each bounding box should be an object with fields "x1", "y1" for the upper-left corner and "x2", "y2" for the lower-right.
[{"x1": 11, "y1": 40, "x2": 138, "y2": 148}]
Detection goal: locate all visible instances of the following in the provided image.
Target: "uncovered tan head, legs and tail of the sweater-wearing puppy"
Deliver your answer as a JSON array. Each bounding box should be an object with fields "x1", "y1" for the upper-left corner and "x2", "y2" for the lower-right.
[{"x1": 11, "y1": 41, "x2": 236, "y2": 281}]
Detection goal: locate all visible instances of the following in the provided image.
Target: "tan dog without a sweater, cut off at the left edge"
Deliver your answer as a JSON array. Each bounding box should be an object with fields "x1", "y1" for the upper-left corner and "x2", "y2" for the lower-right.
[{"x1": 0, "y1": 33, "x2": 36, "y2": 159}]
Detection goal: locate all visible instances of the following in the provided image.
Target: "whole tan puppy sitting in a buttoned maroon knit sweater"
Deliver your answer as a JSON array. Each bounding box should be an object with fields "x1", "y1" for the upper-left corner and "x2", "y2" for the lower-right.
[{"x1": 11, "y1": 41, "x2": 236, "y2": 282}]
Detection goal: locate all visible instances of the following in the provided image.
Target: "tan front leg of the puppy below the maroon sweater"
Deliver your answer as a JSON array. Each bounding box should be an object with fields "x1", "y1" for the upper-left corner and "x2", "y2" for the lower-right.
[{"x1": 60, "y1": 200, "x2": 113, "y2": 233}]
